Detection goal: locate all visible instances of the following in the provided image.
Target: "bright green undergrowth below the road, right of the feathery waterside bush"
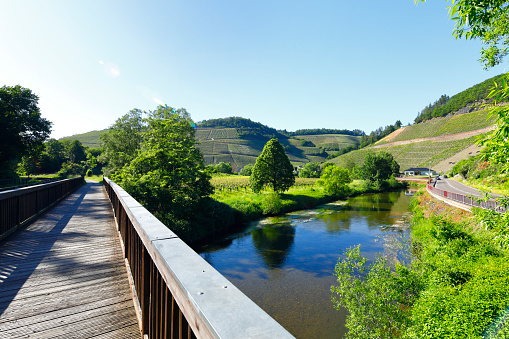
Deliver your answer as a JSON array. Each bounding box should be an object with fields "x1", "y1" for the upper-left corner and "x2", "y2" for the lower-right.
[{"x1": 411, "y1": 190, "x2": 509, "y2": 338}]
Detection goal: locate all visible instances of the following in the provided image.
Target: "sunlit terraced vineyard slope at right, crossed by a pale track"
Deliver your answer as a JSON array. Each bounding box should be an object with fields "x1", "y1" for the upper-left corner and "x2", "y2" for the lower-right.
[{"x1": 331, "y1": 111, "x2": 494, "y2": 173}]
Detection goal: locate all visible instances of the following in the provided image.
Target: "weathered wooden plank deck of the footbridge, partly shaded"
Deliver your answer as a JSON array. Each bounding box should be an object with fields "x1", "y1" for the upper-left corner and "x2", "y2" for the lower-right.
[{"x1": 0, "y1": 183, "x2": 141, "y2": 338}]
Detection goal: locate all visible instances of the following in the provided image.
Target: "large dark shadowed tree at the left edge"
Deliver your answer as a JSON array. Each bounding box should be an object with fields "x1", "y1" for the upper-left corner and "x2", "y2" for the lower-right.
[{"x1": 0, "y1": 85, "x2": 51, "y2": 176}]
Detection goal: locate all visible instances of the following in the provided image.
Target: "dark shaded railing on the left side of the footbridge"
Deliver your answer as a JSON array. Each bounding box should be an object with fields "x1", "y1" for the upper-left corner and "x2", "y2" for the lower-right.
[{"x1": 0, "y1": 177, "x2": 83, "y2": 240}]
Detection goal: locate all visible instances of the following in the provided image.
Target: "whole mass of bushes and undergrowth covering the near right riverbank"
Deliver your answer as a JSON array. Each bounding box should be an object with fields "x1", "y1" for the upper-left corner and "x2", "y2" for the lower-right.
[{"x1": 332, "y1": 204, "x2": 509, "y2": 338}]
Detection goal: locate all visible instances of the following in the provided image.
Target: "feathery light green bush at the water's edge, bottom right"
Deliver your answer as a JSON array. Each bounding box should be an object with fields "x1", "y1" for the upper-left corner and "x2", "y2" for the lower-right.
[{"x1": 331, "y1": 246, "x2": 422, "y2": 338}]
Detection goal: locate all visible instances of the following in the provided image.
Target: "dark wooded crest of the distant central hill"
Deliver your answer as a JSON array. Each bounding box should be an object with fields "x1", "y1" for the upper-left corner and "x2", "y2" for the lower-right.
[{"x1": 196, "y1": 117, "x2": 287, "y2": 139}]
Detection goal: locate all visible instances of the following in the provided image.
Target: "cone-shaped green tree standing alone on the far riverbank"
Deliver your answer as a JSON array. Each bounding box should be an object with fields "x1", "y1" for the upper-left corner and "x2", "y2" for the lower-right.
[{"x1": 249, "y1": 139, "x2": 295, "y2": 193}]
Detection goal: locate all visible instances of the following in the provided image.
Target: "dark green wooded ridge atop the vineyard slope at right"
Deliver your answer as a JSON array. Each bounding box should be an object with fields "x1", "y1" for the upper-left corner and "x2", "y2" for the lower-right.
[{"x1": 415, "y1": 74, "x2": 505, "y2": 123}]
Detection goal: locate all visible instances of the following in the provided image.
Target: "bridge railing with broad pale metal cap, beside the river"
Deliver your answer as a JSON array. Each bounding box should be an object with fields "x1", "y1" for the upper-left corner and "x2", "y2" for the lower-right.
[{"x1": 103, "y1": 178, "x2": 293, "y2": 338}]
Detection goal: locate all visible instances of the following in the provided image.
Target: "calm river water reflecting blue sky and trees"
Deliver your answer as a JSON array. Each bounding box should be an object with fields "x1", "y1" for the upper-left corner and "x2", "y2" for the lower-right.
[{"x1": 194, "y1": 191, "x2": 411, "y2": 338}]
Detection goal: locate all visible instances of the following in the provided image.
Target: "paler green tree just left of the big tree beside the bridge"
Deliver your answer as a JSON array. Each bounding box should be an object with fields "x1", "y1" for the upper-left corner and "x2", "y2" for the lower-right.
[{"x1": 98, "y1": 109, "x2": 146, "y2": 176}]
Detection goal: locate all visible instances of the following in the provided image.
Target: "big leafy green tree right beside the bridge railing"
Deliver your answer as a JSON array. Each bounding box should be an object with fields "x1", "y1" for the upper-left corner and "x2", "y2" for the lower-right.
[{"x1": 112, "y1": 106, "x2": 213, "y2": 234}]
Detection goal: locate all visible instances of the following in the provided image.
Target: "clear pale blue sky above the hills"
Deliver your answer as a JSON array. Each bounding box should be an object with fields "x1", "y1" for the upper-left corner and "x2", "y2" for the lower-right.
[{"x1": 0, "y1": 0, "x2": 506, "y2": 138}]
